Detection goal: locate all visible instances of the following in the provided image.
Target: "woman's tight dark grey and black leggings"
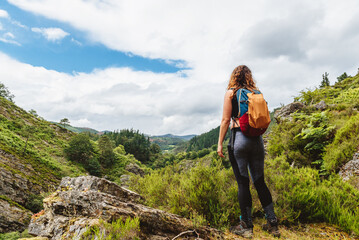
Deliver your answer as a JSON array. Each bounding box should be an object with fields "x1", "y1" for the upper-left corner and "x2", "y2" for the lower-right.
[{"x1": 228, "y1": 129, "x2": 272, "y2": 218}]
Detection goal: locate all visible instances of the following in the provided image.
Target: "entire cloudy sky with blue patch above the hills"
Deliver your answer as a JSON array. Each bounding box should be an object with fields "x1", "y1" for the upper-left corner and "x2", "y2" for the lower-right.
[{"x1": 0, "y1": 0, "x2": 359, "y2": 135}]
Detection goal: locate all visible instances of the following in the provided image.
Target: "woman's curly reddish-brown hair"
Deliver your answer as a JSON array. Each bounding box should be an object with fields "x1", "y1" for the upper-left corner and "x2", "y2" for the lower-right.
[{"x1": 227, "y1": 65, "x2": 258, "y2": 92}]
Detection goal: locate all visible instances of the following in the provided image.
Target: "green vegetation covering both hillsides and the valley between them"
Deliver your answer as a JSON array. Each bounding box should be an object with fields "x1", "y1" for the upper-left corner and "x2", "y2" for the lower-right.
[{"x1": 0, "y1": 74, "x2": 359, "y2": 239}]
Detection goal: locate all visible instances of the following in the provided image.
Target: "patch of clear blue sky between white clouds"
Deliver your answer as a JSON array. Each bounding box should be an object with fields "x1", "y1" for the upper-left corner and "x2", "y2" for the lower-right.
[{"x1": 0, "y1": 1, "x2": 184, "y2": 73}]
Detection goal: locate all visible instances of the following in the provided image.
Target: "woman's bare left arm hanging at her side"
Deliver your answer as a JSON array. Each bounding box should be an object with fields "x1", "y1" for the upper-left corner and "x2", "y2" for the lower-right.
[{"x1": 217, "y1": 90, "x2": 233, "y2": 157}]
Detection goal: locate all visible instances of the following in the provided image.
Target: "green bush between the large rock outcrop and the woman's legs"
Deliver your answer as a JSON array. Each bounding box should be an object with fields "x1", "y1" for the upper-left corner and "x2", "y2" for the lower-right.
[{"x1": 130, "y1": 161, "x2": 239, "y2": 228}]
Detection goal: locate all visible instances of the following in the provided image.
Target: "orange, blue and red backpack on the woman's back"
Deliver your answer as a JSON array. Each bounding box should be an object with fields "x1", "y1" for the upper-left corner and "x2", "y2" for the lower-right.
[{"x1": 237, "y1": 89, "x2": 271, "y2": 136}]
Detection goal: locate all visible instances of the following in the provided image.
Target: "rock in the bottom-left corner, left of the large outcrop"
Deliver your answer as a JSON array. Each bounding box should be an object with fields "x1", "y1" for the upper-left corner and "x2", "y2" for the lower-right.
[{"x1": 0, "y1": 198, "x2": 32, "y2": 233}]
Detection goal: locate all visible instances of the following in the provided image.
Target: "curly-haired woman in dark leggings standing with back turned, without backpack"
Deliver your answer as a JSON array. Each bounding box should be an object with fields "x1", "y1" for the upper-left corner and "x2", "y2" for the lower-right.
[{"x1": 217, "y1": 65, "x2": 280, "y2": 238}]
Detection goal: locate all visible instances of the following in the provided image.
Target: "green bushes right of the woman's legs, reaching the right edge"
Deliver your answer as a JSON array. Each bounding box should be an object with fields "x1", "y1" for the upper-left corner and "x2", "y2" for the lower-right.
[{"x1": 266, "y1": 156, "x2": 359, "y2": 234}]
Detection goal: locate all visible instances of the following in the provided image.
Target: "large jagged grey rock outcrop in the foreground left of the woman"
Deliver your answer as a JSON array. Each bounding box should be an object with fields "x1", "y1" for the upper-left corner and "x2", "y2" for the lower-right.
[{"x1": 29, "y1": 176, "x2": 224, "y2": 240}]
